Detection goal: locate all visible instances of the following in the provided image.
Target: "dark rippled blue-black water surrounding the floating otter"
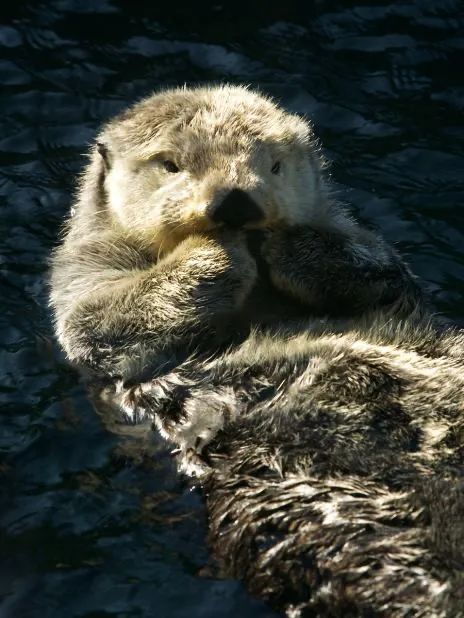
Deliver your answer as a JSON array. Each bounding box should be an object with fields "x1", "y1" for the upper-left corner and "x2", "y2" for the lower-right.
[{"x1": 0, "y1": 0, "x2": 464, "y2": 618}]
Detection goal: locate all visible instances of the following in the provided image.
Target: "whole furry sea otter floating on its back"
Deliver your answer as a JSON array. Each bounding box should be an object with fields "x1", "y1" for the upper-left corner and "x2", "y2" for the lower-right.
[{"x1": 51, "y1": 86, "x2": 464, "y2": 618}]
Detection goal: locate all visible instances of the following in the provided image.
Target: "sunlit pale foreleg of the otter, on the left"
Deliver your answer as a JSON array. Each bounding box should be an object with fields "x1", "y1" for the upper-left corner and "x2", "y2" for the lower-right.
[{"x1": 52, "y1": 234, "x2": 256, "y2": 380}]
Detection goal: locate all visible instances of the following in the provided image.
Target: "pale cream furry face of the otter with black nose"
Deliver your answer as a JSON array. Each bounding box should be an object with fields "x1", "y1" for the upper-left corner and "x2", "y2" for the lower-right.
[{"x1": 99, "y1": 86, "x2": 325, "y2": 249}]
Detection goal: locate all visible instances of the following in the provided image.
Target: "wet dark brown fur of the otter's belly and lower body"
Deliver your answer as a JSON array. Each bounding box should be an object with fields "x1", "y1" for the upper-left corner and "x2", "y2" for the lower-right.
[{"x1": 114, "y1": 323, "x2": 464, "y2": 618}]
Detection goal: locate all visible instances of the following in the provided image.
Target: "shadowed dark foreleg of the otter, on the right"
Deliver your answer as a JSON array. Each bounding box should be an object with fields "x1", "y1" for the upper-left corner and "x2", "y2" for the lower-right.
[{"x1": 262, "y1": 223, "x2": 422, "y2": 316}]
